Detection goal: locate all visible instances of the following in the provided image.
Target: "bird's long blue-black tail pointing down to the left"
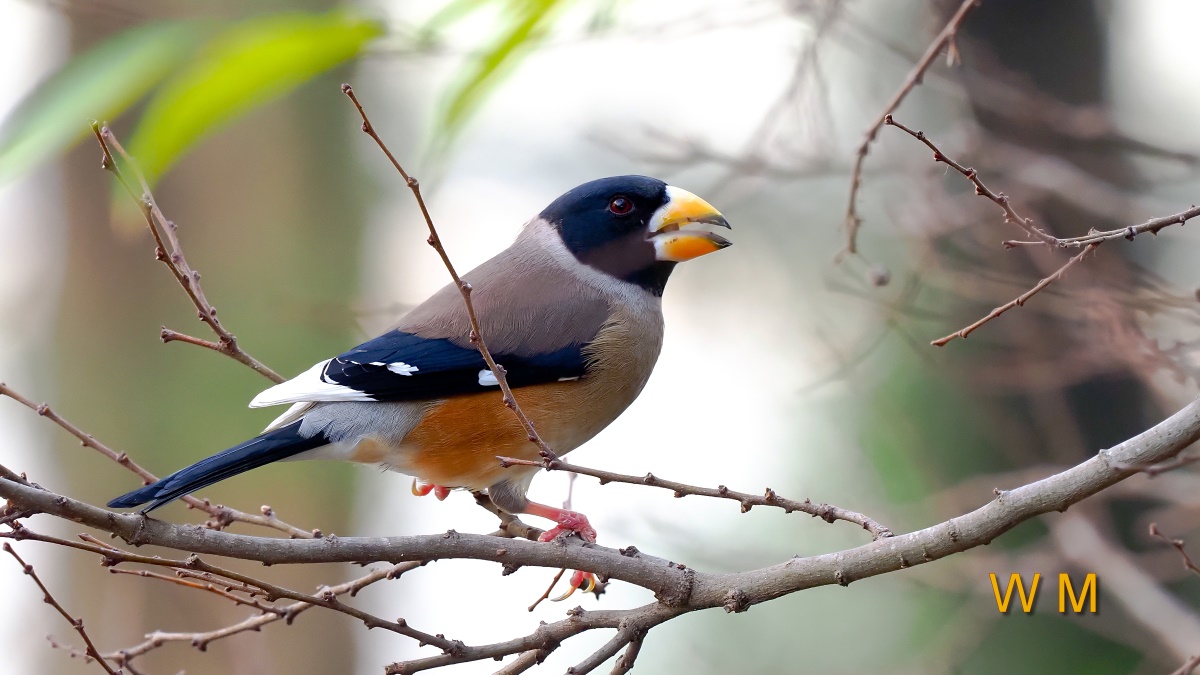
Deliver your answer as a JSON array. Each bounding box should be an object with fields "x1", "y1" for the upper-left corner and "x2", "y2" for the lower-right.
[{"x1": 108, "y1": 420, "x2": 329, "y2": 513}]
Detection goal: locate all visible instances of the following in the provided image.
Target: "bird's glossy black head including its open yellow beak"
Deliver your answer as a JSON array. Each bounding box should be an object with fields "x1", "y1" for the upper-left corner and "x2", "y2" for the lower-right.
[{"x1": 540, "y1": 175, "x2": 728, "y2": 295}]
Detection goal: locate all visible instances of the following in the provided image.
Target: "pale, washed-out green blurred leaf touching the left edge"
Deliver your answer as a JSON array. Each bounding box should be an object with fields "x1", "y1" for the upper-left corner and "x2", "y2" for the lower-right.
[{"x1": 0, "y1": 22, "x2": 208, "y2": 183}]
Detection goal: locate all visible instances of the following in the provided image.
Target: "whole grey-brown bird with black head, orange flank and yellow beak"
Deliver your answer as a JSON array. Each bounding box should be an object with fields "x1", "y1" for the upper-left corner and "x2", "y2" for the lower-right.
[{"x1": 108, "y1": 175, "x2": 731, "y2": 593}]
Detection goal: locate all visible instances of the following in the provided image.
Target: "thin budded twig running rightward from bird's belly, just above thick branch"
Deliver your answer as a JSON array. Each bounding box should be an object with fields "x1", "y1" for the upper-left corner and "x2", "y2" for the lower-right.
[{"x1": 496, "y1": 449, "x2": 892, "y2": 539}]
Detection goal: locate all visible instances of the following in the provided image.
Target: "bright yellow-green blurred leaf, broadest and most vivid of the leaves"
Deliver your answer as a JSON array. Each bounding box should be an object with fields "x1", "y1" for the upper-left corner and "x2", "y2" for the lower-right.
[{"x1": 130, "y1": 11, "x2": 383, "y2": 183}]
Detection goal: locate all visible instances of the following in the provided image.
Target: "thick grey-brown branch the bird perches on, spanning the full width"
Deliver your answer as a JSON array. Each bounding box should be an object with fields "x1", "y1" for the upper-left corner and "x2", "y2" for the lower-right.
[{"x1": 0, "y1": 400, "x2": 1200, "y2": 624}]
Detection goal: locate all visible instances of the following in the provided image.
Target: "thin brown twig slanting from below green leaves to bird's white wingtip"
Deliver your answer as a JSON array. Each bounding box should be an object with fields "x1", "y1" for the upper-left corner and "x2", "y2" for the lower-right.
[{"x1": 91, "y1": 121, "x2": 284, "y2": 384}]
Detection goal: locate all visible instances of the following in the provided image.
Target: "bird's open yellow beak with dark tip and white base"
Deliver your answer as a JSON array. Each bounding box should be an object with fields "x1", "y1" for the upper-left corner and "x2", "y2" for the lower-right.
[{"x1": 647, "y1": 185, "x2": 732, "y2": 263}]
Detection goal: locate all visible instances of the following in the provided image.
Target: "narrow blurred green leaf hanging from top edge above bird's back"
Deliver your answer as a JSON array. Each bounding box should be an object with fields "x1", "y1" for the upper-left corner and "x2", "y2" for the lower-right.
[{"x1": 434, "y1": 0, "x2": 565, "y2": 148}]
